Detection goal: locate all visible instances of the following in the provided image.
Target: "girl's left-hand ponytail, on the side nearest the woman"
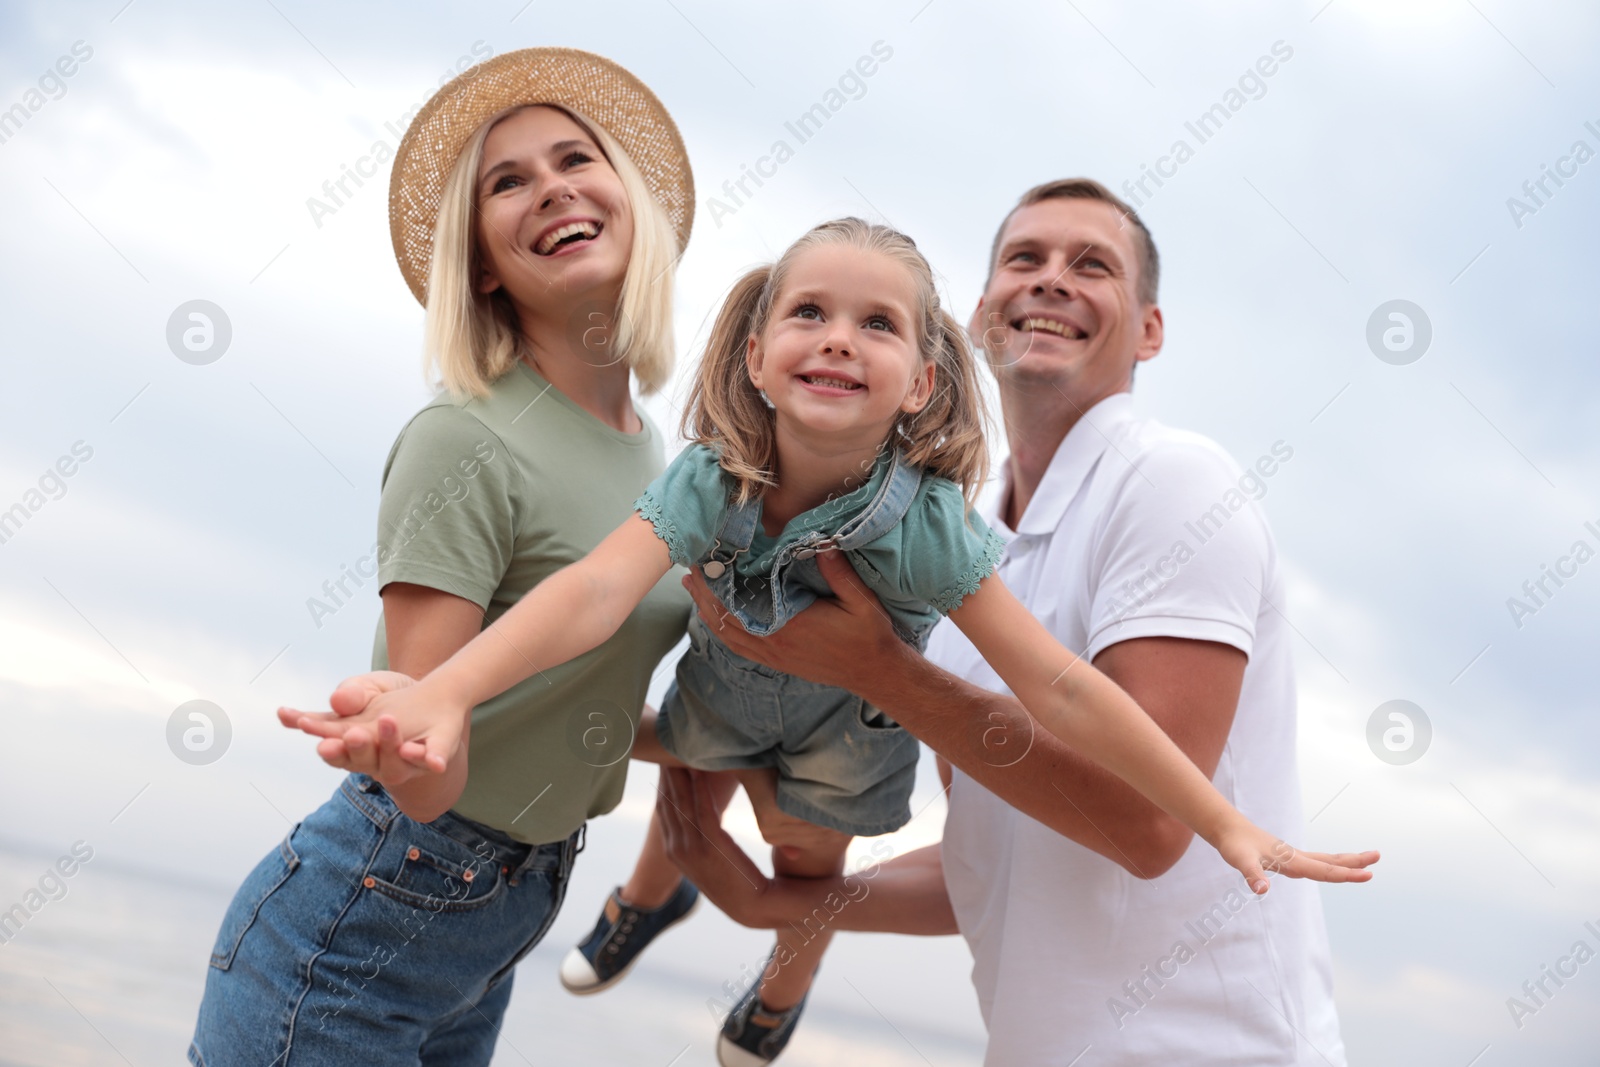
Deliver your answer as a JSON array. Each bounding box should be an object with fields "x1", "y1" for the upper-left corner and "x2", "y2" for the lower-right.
[{"x1": 682, "y1": 266, "x2": 778, "y2": 502}]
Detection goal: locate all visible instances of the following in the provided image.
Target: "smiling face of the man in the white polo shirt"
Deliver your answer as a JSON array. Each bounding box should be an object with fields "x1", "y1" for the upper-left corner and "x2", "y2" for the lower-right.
[{"x1": 970, "y1": 197, "x2": 1162, "y2": 403}]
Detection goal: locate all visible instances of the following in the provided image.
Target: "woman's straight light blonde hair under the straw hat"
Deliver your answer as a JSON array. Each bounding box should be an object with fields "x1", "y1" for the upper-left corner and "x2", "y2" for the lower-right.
[{"x1": 422, "y1": 104, "x2": 678, "y2": 397}]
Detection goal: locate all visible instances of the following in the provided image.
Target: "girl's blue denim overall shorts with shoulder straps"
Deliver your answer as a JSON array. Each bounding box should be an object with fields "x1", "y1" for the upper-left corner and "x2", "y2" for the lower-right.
[{"x1": 656, "y1": 451, "x2": 938, "y2": 837}]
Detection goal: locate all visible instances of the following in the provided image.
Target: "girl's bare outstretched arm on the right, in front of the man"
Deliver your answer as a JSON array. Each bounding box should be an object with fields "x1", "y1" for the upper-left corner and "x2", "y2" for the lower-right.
[{"x1": 950, "y1": 574, "x2": 1376, "y2": 893}]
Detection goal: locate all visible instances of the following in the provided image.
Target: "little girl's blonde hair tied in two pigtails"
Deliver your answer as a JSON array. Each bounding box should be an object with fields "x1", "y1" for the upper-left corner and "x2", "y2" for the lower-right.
[{"x1": 682, "y1": 218, "x2": 989, "y2": 506}]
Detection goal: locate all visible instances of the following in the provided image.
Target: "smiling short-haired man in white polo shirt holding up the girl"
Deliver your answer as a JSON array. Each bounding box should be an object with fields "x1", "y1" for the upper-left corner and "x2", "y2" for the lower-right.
[{"x1": 661, "y1": 179, "x2": 1350, "y2": 1067}]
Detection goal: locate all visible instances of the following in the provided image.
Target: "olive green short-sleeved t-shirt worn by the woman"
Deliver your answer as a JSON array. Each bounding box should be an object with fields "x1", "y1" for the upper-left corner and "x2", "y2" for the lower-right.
[{"x1": 373, "y1": 363, "x2": 690, "y2": 845}]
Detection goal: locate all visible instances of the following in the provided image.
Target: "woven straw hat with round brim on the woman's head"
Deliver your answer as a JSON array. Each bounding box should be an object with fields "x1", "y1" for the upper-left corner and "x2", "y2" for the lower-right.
[{"x1": 389, "y1": 48, "x2": 694, "y2": 304}]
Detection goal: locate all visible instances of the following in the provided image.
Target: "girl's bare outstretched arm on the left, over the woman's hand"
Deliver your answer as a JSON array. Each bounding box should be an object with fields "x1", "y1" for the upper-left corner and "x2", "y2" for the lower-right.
[{"x1": 291, "y1": 515, "x2": 672, "y2": 773}]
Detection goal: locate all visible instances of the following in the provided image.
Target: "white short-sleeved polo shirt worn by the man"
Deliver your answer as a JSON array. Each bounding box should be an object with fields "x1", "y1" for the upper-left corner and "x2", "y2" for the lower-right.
[{"x1": 928, "y1": 394, "x2": 1344, "y2": 1067}]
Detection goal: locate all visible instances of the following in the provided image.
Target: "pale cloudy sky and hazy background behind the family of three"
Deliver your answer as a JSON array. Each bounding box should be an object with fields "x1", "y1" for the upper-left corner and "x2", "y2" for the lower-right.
[{"x1": 0, "y1": 0, "x2": 1600, "y2": 1065}]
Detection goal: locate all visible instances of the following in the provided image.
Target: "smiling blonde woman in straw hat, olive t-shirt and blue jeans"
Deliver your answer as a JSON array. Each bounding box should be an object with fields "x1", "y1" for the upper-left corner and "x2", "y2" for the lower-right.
[{"x1": 189, "y1": 50, "x2": 693, "y2": 1067}]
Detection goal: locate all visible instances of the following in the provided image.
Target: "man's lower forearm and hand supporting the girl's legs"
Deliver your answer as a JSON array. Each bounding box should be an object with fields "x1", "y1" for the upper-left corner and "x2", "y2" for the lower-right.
[{"x1": 656, "y1": 766, "x2": 957, "y2": 934}]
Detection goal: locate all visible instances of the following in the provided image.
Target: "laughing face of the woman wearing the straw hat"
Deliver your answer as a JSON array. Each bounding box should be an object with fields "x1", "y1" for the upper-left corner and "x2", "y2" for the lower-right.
[{"x1": 474, "y1": 107, "x2": 634, "y2": 309}]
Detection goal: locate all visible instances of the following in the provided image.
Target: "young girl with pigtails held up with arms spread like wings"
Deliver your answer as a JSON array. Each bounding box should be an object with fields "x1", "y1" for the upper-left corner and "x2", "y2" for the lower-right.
[{"x1": 302, "y1": 219, "x2": 1370, "y2": 1065}]
